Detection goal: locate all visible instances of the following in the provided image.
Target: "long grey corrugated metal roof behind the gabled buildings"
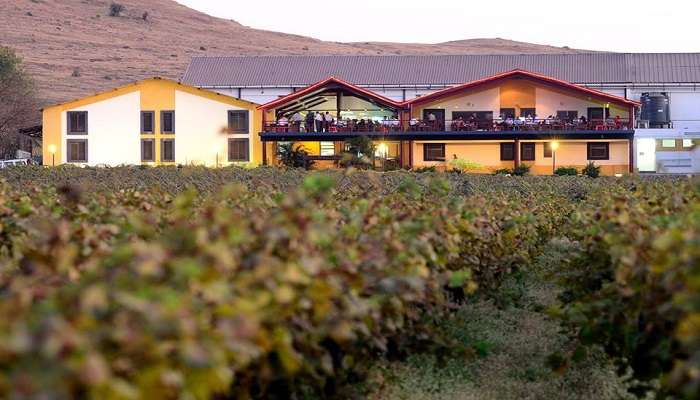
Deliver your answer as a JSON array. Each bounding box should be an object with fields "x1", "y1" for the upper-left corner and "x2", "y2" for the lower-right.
[{"x1": 183, "y1": 53, "x2": 700, "y2": 87}]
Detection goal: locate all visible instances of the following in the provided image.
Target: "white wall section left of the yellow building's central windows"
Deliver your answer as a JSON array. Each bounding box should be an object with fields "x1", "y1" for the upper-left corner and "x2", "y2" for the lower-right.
[{"x1": 61, "y1": 91, "x2": 141, "y2": 166}]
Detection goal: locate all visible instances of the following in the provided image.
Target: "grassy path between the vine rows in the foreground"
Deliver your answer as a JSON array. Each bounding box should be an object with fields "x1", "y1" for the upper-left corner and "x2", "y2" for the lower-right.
[{"x1": 367, "y1": 268, "x2": 629, "y2": 400}]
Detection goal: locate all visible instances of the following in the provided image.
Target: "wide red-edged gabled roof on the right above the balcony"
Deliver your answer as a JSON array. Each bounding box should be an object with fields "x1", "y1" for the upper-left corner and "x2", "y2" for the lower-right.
[{"x1": 404, "y1": 69, "x2": 640, "y2": 106}]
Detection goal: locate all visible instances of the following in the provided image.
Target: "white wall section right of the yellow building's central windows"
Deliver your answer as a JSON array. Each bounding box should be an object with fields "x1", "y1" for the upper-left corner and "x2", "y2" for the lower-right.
[{"x1": 175, "y1": 90, "x2": 254, "y2": 166}]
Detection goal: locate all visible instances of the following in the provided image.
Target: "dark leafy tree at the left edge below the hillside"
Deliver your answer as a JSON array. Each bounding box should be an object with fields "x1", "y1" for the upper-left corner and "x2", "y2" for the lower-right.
[{"x1": 0, "y1": 47, "x2": 38, "y2": 158}]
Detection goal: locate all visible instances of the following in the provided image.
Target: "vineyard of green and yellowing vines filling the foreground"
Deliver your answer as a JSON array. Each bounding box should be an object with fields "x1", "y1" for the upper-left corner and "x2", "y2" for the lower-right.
[{"x1": 0, "y1": 167, "x2": 700, "y2": 399}]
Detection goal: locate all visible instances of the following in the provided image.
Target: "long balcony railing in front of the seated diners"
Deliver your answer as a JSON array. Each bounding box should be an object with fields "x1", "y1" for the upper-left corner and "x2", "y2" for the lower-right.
[{"x1": 264, "y1": 119, "x2": 632, "y2": 134}]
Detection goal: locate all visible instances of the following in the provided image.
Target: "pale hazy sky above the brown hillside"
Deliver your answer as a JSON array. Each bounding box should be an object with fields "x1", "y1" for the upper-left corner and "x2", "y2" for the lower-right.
[{"x1": 172, "y1": 0, "x2": 700, "y2": 52}]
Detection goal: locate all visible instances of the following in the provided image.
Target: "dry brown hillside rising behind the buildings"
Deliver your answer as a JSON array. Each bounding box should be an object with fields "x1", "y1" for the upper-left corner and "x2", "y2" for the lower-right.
[{"x1": 0, "y1": 0, "x2": 592, "y2": 103}]
